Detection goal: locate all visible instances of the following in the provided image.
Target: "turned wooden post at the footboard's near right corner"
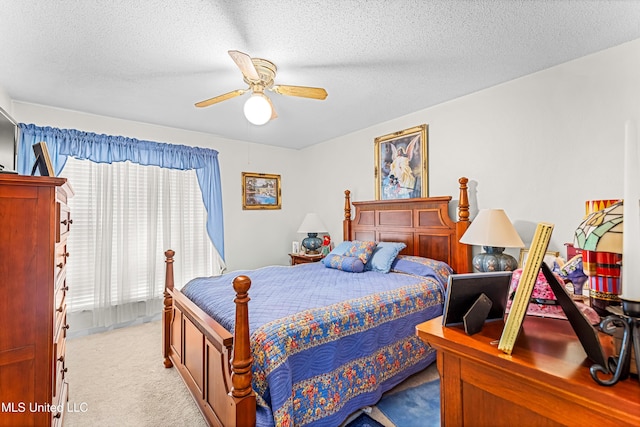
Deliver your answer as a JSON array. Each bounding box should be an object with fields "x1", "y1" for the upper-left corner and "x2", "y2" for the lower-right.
[{"x1": 231, "y1": 276, "x2": 253, "y2": 397}]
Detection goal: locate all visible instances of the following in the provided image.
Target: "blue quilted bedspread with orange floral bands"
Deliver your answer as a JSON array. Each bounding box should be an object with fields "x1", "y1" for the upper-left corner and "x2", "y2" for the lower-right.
[{"x1": 182, "y1": 263, "x2": 443, "y2": 426}]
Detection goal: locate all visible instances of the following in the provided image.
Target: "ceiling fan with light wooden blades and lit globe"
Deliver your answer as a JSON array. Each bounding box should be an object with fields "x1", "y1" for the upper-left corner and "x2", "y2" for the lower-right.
[{"x1": 196, "y1": 50, "x2": 327, "y2": 125}]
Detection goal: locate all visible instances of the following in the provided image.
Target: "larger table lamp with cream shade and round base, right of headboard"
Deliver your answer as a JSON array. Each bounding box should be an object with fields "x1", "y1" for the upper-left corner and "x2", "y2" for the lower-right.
[{"x1": 460, "y1": 209, "x2": 524, "y2": 272}]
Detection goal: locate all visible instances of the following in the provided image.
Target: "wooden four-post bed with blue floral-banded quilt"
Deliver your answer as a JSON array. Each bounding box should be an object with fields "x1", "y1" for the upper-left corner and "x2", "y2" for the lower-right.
[{"x1": 162, "y1": 178, "x2": 471, "y2": 427}]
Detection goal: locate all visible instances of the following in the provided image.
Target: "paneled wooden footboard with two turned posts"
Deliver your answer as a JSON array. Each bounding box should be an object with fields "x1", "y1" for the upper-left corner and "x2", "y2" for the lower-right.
[{"x1": 162, "y1": 250, "x2": 256, "y2": 427}]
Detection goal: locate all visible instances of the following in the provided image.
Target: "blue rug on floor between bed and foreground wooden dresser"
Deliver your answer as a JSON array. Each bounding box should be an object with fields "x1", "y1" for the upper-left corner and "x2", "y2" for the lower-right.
[{"x1": 376, "y1": 380, "x2": 440, "y2": 427}]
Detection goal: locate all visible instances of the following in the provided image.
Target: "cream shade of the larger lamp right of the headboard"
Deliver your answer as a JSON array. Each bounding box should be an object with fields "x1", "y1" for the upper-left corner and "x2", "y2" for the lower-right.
[{"x1": 460, "y1": 209, "x2": 524, "y2": 248}]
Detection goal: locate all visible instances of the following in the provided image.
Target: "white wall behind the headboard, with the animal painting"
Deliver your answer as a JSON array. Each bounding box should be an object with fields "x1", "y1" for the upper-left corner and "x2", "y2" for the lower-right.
[{"x1": 304, "y1": 40, "x2": 640, "y2": 258}]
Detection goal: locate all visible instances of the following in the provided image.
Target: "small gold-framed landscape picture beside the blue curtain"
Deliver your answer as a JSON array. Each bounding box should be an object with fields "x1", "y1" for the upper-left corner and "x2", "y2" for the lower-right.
[{"x1": 242, "y1": 172, "x2": 282, "y2": 210}]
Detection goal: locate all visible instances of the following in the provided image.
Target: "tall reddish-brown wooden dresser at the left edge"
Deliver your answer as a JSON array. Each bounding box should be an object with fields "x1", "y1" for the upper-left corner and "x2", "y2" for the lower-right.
[{"x1": 0, "y1": 174, "x2": 73, "y2": 426}]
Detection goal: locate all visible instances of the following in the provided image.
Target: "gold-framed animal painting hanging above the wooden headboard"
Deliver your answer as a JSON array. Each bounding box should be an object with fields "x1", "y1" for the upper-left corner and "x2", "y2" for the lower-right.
[{"x1": 374, "y1": 124, "x2": 429, "y2": 200}]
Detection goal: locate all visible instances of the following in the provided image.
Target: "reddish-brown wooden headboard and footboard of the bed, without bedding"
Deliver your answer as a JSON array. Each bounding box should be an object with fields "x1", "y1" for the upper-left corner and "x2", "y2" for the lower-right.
[{"x1": 162, "y1": 178, "x2": 471, "y2": 427}]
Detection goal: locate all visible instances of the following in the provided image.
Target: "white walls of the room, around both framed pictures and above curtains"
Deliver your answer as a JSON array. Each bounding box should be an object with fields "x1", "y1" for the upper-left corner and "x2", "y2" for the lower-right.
[{"x1": 5, "y1": 40, "x2": 640, "y2": 270}]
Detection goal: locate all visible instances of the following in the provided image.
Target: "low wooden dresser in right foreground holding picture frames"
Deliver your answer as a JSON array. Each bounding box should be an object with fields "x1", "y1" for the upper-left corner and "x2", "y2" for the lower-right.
[{"x1": 416, "y1": 316, "x2": 640, "y2": 427}]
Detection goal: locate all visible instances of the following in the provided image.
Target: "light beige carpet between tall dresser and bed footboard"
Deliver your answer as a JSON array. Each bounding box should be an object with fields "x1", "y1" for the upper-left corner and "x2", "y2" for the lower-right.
[{"x1": 64, "y1": 321, "x2": 206, "y2": 427}]
